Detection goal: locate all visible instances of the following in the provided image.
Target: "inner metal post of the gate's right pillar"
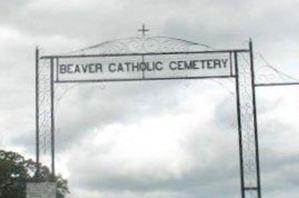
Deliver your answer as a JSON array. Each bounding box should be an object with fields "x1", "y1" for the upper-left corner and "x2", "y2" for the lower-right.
[{"x1": 234, "y1": 52, "x2": 245, "y2": 198}]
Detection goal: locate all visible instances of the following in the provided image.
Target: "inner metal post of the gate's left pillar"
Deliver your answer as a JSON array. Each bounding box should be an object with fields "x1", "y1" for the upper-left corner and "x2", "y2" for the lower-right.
[{"x1": 50, "y1": 58, "x2": 55, "y2": 179}]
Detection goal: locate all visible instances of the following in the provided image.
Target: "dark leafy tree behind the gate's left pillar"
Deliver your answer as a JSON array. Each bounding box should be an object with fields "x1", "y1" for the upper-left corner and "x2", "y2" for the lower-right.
[{"x1": 0, "y1": 150, "x2": 69, "y2": 198}]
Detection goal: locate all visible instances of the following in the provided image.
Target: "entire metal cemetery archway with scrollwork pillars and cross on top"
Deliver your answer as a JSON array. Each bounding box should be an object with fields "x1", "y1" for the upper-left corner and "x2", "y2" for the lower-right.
[{"x1": 36, "y1": 33, "x2": 261, "y2": 198}]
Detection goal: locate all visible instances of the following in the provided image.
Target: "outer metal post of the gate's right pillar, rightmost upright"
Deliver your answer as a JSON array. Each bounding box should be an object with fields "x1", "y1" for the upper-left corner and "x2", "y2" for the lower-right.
[{"x1": 249, "y1": 39, "x2": 261, "y2": 198}]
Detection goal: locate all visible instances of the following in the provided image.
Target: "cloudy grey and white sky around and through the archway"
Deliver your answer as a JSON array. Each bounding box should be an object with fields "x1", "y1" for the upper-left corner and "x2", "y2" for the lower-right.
[{"x1": 0, "y1": 0, "x2": 299, "y2": 198}]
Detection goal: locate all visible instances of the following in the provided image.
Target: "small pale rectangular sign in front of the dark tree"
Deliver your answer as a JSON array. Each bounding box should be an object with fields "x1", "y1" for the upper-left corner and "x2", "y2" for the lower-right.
[{"x1": 26, "y1": 182, "x2": 57, "y2": 198}]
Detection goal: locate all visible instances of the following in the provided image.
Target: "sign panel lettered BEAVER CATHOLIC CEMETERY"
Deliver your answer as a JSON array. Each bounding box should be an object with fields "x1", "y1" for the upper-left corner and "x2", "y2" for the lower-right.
[{"x1": 54, "y1": 53, "x2": 232, "y2": 82}]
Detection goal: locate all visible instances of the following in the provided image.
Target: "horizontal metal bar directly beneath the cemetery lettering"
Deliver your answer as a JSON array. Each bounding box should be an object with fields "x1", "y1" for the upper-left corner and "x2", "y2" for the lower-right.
[{"x1": 55, "y1": 75, "x2": 235, "y2": 83}]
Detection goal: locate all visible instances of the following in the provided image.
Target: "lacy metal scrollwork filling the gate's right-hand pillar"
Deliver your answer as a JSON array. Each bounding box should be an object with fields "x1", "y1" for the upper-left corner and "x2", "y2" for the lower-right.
[{"x1": 238, "y1": 54, "x2": 258, "y2": 195}]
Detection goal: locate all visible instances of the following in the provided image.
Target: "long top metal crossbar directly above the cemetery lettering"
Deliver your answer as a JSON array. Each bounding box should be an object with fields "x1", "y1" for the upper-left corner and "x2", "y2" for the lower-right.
[{"x1": 40, "y1": 49, "x2": 249, "y2": 59}]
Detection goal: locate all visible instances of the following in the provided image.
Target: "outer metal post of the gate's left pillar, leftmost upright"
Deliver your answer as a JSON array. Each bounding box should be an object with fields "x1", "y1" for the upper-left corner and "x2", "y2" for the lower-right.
[{"x1": 35, "y1": 47, "x2": 40, "y2": 177}]
